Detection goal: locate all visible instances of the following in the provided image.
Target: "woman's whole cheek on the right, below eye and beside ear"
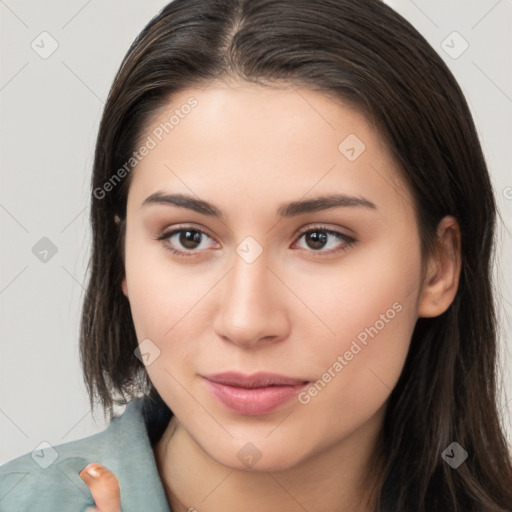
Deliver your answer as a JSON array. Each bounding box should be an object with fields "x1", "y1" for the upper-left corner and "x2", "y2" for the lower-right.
[{"x1": 296, "y1": 235, "x2": 421, "y2": 416}]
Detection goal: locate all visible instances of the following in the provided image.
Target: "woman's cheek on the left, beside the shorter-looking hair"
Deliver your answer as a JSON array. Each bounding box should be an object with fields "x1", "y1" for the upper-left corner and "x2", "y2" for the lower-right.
[{"x1": 126, "y1": 238, "x2": 214, "y2": 406}]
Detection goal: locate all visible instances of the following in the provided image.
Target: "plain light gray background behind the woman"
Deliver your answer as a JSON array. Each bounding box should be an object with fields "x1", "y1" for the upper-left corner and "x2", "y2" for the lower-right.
[{"x1": 0, "y1": 0, "x2": 512, "y2": 464}]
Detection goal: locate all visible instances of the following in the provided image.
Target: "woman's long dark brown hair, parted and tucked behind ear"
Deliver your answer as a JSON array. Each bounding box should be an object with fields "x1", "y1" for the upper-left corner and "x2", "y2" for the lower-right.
[{"x1": 80, "y1": 0, "x2": 512, "y2": 512}]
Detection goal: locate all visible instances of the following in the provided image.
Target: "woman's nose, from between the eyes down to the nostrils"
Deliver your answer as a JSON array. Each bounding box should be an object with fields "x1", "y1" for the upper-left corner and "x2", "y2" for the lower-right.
[{"x1": 214, "y1": 247, "x2": 290, "y2": 348}]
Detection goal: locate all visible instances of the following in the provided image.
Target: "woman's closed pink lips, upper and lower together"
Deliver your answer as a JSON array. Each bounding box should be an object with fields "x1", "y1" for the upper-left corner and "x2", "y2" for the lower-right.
[{"x1": 202, "y1": 372, "x2": 309, "y2": 416}]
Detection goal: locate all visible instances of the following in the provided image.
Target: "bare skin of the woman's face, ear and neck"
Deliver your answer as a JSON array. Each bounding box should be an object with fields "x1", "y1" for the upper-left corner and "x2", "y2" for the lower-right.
[{"x1": 115, "y1": 82, "x2": 460, "y2": 512}]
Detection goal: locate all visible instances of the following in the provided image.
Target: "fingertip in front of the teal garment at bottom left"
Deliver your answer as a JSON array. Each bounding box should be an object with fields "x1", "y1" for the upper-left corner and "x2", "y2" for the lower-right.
[{"x1": 80, "y1": 462, "x2": 121, "y2": 512}]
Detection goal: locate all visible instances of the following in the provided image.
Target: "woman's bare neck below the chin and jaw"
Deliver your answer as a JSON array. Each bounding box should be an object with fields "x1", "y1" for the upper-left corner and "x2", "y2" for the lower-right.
[{"x1": 155, "y1": 409, "x2": 384, "y2": 512}]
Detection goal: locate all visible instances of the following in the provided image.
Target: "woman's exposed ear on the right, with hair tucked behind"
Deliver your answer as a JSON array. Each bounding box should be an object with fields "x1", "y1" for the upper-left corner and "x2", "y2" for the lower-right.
[{"x1": 418, "y1": 216, "x2": 461, "y2": 318}]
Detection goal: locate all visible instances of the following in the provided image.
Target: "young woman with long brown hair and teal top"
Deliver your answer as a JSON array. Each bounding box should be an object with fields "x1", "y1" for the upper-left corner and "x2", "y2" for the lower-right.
[{"x1": 0, "y1": 0, "x2": 512, "y2": 512}]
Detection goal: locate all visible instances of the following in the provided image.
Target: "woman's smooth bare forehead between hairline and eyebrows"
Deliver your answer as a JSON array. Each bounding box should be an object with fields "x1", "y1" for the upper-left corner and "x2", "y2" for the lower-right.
[{"x1": 129, "y1": 83, "x2": 410, "y2": 218}]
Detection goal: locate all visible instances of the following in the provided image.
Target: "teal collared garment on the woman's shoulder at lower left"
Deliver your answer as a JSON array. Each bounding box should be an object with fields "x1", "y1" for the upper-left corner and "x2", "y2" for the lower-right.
[{"x1": 0, "y1": 397, "x2": 172, "y2": 512}]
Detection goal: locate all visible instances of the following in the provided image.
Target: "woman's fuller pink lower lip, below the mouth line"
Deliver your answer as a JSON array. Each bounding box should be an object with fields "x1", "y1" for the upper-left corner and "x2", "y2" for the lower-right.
[{"x1": 205, "y1": 379, "x2": 307, "y2": 416}]
